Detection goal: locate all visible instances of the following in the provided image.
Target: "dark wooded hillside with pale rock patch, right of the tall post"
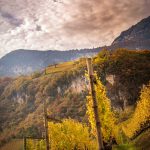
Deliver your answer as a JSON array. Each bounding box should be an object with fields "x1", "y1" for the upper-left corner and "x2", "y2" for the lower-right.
[{"x1": 95, "y1": 49, "x2": 150, "y2": 109}]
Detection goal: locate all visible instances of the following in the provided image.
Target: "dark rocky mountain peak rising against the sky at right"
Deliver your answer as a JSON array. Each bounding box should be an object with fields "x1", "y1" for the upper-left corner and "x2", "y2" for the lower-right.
[{"x1": 111, "y1": 16, "x2": 150, "y2": 50}]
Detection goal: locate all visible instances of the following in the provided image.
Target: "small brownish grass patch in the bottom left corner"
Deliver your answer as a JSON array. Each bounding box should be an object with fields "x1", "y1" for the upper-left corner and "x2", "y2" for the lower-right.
[{"x1": 0, "y1": 139, "x2": 23, "y2": 150}]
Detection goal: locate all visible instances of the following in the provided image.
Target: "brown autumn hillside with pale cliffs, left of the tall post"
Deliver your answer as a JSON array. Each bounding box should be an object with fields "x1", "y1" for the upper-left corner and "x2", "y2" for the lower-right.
[{"x1": 0, "y1": 61, "x2": 87, "y2": 146}]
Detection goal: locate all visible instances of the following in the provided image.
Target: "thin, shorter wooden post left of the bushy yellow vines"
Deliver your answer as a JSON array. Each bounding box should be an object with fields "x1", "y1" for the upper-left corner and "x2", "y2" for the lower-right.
[{"x1": 44, "y1": 100, "x2": 50, "y2": 150}]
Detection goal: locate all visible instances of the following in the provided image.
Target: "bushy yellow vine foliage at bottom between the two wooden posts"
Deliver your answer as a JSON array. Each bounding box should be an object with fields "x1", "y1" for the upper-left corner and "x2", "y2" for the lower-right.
[{"x1": 49, "y1": 119, "x2": 96, "y2": 150}]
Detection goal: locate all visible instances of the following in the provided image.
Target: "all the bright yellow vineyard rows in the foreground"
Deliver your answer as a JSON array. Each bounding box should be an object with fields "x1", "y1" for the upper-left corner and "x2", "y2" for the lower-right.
[{"x1": 21, "y1": 72, "x2": 150, "y2": 150}]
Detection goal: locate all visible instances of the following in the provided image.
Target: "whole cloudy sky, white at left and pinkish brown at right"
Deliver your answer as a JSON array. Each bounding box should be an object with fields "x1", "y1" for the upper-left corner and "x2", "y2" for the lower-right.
[{"x1": 0, "y1": 0, "x2": 150, "y2": 57}]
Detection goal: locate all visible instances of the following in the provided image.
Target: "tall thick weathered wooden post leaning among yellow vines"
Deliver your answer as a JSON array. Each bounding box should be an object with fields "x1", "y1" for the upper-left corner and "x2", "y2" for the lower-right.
[{"x1": 86, "y1": 58, "x2": 104, "y2": 150}]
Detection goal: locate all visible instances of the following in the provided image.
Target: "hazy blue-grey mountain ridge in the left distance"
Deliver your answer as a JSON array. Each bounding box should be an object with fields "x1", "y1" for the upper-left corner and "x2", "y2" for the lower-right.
[{"x1": 0, "y1": 48, "x2": 100, "y2": 76}]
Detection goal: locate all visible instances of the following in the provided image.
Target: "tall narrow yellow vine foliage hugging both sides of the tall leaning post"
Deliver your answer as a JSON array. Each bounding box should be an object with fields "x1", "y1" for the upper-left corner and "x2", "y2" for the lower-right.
[{"x1": 87, "y1": 74, "x2": 116, "y2": 141}]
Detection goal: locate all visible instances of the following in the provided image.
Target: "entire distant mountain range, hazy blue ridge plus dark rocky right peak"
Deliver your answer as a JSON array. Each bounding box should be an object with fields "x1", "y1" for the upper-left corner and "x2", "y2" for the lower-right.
[{"x1": 0, "y1": 17, "x2": 150, "y2": 76}]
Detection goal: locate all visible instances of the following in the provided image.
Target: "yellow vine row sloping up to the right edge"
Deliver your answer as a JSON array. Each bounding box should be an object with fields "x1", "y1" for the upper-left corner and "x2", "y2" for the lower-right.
[{"x1": 122, "y1": 83, "x2": 150, "y2": 138}]
